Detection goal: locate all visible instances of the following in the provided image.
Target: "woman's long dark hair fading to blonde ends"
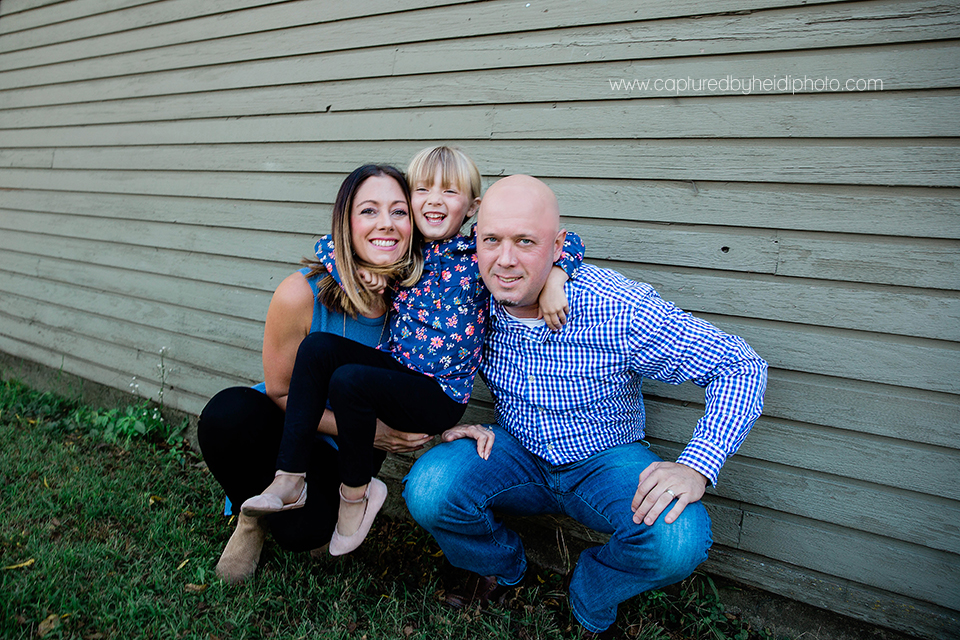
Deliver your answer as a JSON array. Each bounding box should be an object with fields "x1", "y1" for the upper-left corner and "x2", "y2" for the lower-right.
[{"x1": 302, "y1": 164, "x2": 423, "y2": 317}]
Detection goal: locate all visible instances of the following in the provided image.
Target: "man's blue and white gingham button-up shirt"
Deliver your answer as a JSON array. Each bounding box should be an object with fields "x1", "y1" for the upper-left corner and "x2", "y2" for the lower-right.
[{"x1": 483, "y1": 264, "x2": 767, "y2": 483}]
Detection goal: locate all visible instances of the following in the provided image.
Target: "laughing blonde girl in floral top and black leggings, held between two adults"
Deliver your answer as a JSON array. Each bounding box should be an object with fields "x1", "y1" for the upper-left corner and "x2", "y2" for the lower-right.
[{"x1": 242, "y1": 147, "x2": 583, "y2": 555}]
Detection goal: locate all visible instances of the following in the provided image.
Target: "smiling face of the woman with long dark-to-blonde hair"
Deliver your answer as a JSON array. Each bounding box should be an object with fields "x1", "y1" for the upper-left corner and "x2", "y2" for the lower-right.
[{"x1": 350, "y1": 176, "x2": 411, "y2": 265}]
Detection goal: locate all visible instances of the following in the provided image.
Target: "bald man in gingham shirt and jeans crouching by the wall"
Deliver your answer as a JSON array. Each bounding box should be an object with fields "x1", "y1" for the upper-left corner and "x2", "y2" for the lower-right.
[{"x1": 404, "y1": 176, "x2": 766, "y2": 637}]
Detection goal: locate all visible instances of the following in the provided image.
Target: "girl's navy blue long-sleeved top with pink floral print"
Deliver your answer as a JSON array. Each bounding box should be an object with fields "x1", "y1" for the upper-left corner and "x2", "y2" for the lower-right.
[{"x1": 316, "y1": 225, "x2": 584, "y2": 403}]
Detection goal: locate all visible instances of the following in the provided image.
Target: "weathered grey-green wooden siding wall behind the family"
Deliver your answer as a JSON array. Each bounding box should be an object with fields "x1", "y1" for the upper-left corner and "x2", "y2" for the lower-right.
[{"x1": 0, "y1": 0, "x2": 960, "y2": 638}]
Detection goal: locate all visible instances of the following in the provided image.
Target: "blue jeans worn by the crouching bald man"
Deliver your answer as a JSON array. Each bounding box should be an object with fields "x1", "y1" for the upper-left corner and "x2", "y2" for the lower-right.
[{"x1": 403, "y1": 427, "x2": 712, "y2": 632}]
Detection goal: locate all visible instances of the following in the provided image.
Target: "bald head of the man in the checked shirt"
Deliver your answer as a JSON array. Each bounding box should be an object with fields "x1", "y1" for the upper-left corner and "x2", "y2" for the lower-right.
[{"x1": 477, "y1": 176, "x2": 564, "y2": 318}]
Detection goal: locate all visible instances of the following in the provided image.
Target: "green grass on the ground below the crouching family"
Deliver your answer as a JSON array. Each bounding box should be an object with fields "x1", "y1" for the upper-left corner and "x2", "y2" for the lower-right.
[{"x1": 0, "y1": 381, "x2": 770, "y2": 640}]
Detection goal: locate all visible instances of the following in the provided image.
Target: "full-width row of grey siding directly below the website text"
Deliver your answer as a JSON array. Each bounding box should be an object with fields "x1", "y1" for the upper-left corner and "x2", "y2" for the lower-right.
[{"x1": 0, "y1": 92, "x2": 960, "y2": 147}]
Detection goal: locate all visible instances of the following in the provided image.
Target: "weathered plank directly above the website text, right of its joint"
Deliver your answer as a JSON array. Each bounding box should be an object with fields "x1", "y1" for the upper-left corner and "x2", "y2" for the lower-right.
[{"x1": 394, "y1": 1, "x2": 960, "y2": 80}]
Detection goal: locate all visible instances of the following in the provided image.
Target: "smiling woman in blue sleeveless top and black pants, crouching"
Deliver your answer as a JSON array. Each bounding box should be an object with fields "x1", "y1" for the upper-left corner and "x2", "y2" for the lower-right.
[{"x1": 198, "y1": 165, "x2": 430, "y2": 582}]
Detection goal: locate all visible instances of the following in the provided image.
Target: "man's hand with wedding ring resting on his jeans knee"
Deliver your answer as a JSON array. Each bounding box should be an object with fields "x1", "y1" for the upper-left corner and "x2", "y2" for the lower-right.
[{"x1": 630, "y1": 462, "x2": 707, "y2": 526}]
